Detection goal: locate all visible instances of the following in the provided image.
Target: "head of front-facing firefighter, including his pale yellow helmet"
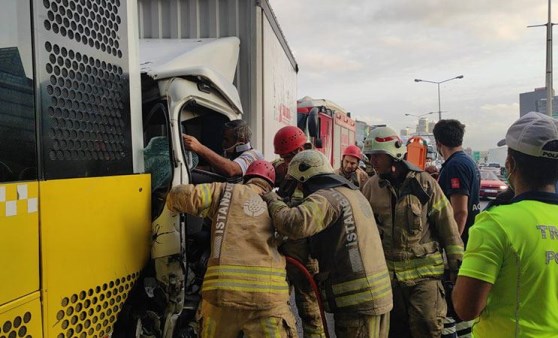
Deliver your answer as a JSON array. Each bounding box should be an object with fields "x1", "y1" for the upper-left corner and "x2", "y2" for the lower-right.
[{"x1": 362, "y1": 127, "x2": 406, "y2": 175}]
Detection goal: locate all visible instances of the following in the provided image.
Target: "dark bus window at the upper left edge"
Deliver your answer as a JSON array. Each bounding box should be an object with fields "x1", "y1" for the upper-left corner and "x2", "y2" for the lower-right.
[{"x1": 0, "y1": 0, "x2": 37, "y2": 182}]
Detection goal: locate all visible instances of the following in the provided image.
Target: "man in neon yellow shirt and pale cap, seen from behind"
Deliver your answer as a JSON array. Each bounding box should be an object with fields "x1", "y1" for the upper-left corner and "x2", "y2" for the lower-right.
[{"x1": 453, "y1": 112, "x2": 558, "y2": 338}]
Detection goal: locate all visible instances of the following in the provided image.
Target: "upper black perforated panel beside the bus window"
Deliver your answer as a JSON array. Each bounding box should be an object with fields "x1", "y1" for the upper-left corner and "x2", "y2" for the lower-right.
[{"x1": 35, "y1": 0, "x2": 133, "y2": 179}]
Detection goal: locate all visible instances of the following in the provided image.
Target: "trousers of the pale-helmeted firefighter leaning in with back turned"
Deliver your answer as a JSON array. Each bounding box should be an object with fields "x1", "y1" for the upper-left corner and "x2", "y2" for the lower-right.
[{"x1": 333, "y1": 312, "x2": 389, "y2": 338}]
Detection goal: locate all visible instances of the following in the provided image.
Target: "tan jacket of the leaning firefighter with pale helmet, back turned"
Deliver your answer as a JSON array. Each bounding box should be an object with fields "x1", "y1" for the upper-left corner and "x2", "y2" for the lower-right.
[{"x1": 264, "y1": 186, "x2": 393, "y2": 315}]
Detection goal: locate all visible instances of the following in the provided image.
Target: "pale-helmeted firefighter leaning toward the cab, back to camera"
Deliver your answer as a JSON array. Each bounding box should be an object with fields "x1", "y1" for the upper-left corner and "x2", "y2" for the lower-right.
[{"x1": 264, "y1": 150, "x2": 392, "y2": 337}]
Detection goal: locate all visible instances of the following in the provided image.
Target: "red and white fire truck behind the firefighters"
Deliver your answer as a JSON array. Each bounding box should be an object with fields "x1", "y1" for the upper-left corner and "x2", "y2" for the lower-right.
[{"x1": 297, "y1": 96, "x2": 355, "y2": 168}]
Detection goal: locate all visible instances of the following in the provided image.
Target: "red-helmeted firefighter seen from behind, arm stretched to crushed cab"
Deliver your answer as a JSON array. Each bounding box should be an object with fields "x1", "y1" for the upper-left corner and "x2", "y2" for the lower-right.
[{"x1": 167, "y1": 160, "x2": 297, "y2": 338}]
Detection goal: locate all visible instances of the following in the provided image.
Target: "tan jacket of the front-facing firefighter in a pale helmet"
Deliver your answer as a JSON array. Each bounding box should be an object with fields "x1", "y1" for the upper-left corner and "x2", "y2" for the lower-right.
[{"x1": 362, "y1": 164, "x2": 463, "y2": 285}]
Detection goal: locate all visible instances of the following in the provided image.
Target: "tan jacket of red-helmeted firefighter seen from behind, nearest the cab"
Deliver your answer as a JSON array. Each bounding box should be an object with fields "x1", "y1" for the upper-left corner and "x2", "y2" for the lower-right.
[{"x1": 167, "y1": 178, "x2": 289, "y2": 310}]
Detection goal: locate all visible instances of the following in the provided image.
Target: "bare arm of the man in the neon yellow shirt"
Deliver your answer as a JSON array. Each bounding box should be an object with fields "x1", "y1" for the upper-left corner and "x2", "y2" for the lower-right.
[{"x1": 451, "y1": 276, "x2": 492, "y2": 320}]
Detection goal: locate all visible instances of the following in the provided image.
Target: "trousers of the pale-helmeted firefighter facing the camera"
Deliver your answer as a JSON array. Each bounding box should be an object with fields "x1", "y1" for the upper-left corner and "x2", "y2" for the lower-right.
[{"x1": 389, "y1": 279, "x2": 447, "y2": 338}]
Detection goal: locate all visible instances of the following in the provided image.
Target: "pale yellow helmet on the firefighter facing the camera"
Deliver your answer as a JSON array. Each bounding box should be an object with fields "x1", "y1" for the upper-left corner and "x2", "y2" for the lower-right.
[{"x1": 362, "y1": 127, "x2": 406, "y2": 160}]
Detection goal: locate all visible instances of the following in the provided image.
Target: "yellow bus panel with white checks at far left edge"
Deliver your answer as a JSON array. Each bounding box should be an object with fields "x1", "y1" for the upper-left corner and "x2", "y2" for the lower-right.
[{"x1": 0, "y1": 182, "x2": 39, "y2": 305}]
